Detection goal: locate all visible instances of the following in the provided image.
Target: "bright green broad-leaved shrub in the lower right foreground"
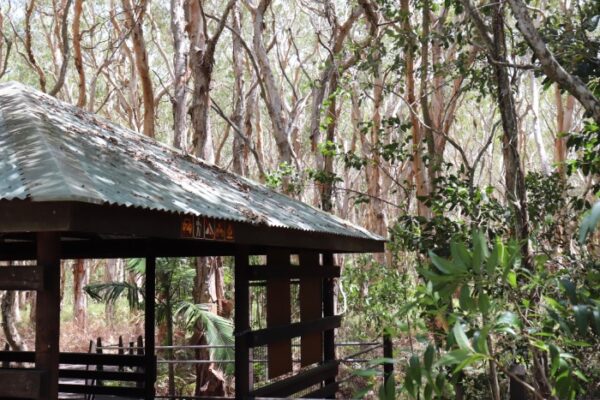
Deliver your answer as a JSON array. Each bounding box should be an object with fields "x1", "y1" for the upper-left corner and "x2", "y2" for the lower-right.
[{"x1": 394, "y1": 231, "x2": 600, "y2": 399}]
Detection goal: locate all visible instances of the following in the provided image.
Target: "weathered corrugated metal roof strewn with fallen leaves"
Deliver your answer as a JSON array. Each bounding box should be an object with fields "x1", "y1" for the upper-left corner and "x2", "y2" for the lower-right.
[{"x1": 0, "y1": 82, "x2": 382, "y2": 240}]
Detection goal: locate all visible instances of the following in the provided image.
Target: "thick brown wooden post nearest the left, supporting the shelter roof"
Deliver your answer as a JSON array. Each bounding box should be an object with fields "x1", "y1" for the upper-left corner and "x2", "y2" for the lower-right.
[{"x1": 35, "y1": 232, "x2": 60, "y2": 400}]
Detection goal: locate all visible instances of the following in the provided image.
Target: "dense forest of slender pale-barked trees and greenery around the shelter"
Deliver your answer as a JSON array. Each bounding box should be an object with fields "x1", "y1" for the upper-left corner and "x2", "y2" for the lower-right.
[{"x1": 0, "y1": 0, "x2": 600, "y2": 400}]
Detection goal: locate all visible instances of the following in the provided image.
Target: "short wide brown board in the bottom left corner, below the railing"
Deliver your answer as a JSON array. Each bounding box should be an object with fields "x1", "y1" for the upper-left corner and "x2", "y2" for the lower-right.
[{"x1": 0, "y1": 368, "x2": 44, "y2": 399}]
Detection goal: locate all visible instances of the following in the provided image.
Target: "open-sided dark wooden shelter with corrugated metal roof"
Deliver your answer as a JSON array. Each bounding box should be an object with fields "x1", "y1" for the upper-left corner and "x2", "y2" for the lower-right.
[{"x1": 0, "y1": 82, "x2": 384, "y2": 399}]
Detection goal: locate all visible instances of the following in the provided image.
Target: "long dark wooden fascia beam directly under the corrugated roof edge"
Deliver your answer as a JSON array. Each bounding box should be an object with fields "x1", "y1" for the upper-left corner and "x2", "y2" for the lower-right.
[{"x1": 0, "y1": 201, "x2": 385, "y2": 253}]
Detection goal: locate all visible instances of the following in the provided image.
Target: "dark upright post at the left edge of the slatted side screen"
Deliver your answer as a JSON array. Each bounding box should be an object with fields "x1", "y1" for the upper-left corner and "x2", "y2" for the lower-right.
[{"x1": 234, "y1": 248, "x2": 253, "y2": 399}]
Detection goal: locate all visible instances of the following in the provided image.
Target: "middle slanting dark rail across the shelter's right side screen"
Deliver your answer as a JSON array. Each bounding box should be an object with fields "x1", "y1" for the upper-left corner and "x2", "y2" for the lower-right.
[{"x1": 246, "y1": 315, "x2": 342, "y2": 347}]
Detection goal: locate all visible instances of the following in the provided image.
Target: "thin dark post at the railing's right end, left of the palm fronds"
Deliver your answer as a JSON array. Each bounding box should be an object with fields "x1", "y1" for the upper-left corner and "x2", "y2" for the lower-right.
[{"x1": 144, "y1": 256, "x2": 156, "y2": 400}]
